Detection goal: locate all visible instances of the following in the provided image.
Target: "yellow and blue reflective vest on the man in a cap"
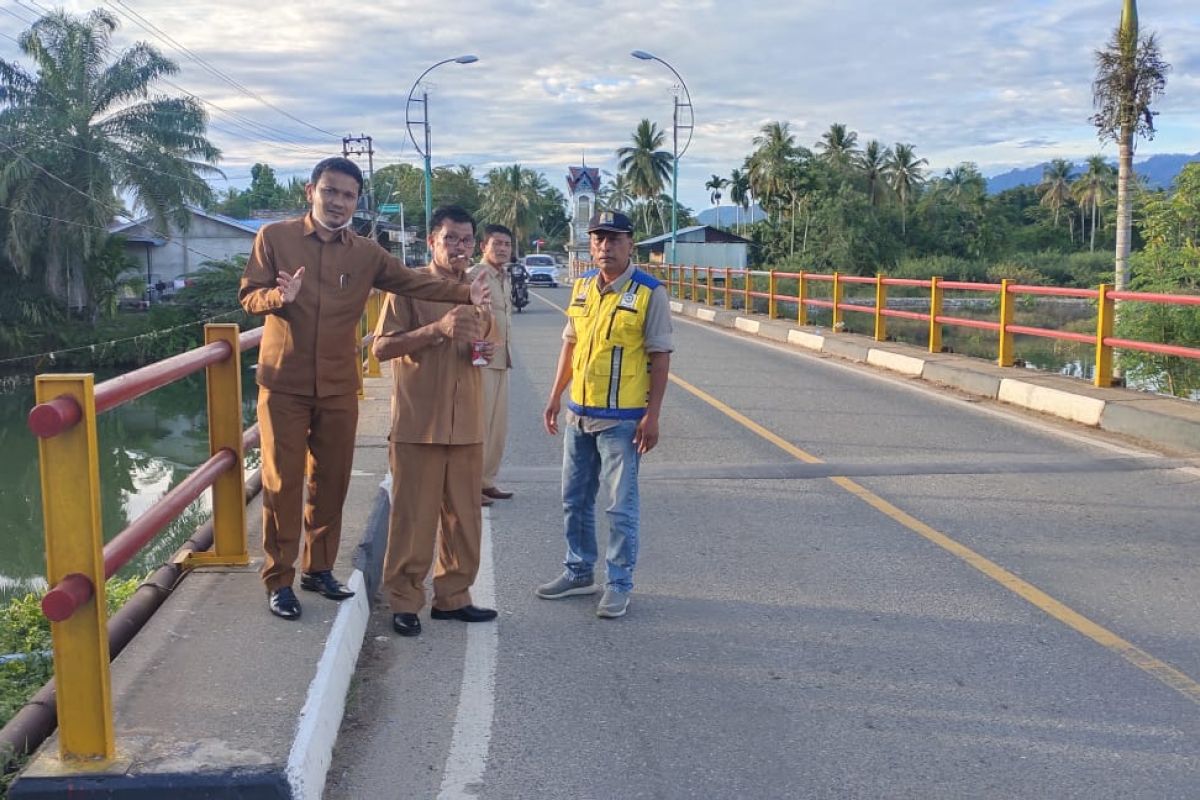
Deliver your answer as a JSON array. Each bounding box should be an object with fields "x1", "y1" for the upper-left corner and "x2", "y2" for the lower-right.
[{"x1": 566, "y1": 269, "x2": 659, "y2": 420}]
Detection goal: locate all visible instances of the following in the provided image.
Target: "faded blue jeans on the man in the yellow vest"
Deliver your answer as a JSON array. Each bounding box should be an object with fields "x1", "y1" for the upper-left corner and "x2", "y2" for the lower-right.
[{"x1": 563, "y1": 420, "x2": 641, "y2": 591}]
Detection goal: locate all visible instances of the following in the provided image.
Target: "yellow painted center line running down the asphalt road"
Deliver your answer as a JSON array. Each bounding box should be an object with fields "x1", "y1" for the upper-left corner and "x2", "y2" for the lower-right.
[{"x1": 671, "y1": 373, "x2": 1200, "y2": 704}]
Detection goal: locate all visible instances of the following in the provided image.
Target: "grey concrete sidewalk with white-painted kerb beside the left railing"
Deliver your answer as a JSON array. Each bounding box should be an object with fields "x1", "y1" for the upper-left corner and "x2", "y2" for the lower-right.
[{"x1": 11, "y1": 379, "x2": 390, "y2": 800}]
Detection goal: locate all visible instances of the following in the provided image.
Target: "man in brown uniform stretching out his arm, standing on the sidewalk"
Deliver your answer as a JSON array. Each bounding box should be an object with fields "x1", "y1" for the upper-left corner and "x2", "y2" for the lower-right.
[{"x1": 238, "y1": 158, "x2": 488, "y2": 619}]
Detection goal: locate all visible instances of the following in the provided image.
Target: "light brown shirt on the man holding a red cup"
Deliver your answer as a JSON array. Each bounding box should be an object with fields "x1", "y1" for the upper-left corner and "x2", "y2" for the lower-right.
[{"x1": 376, "y1": 266, "x2": 490, "y2": 445}]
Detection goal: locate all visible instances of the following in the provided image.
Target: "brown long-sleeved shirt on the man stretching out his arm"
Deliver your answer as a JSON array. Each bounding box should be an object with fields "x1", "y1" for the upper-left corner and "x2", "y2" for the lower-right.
[{"x1": 238, "y1": 213, "x2": 470, "y2": 397}]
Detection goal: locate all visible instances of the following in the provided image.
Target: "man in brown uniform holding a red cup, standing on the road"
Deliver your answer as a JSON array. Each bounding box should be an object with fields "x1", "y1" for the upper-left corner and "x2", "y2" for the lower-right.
[{"x1": 371, "y1": 206, "x2": 496, "y2": 636}]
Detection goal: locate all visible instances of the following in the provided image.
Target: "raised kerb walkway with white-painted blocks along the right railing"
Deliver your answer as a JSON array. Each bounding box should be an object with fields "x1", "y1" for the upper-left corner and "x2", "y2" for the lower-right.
[{"x1": 671, "y1": 300, "x2": 1200, "y2": 453}]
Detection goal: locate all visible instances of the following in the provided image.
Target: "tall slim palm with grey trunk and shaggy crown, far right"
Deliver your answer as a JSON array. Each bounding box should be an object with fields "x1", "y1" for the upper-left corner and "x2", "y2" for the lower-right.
[{"x1": 1092, "y1": 0, "x2": 1170, "y2": 291}]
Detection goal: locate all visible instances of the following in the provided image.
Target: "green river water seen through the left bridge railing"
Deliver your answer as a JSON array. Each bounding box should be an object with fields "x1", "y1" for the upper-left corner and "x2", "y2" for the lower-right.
[{"x1": 0, "y1": 368, "x2": 257, "y2": 600}]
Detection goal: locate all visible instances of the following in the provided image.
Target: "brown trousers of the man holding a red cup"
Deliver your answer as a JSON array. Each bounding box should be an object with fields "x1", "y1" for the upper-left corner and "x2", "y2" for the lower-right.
[{"x1": 383, "y1": 441, "x2": 484, "y2": 614}]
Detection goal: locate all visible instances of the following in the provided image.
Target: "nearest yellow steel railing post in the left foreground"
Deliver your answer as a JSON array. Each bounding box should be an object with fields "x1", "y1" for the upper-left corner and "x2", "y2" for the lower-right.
[{"x1": 35, "y1": 374, "x2": 115, "y2": 762}]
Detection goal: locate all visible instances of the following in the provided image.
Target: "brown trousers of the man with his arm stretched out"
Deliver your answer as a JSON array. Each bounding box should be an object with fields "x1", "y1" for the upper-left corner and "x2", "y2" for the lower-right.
[{"x1": 258, "y1": 387, "x2": 359, "y2": 591}]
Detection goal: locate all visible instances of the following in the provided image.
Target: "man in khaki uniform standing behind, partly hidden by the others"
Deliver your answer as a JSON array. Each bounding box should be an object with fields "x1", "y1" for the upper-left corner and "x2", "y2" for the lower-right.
[{"x1": 468, "y1": 224, "x2": 512, "y2": 505}]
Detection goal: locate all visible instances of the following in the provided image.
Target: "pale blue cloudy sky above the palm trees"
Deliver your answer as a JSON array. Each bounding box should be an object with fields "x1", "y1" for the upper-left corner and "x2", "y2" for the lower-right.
[{"x1": 0, "y1": 0, "x2": 1200, "y2": 210}]
